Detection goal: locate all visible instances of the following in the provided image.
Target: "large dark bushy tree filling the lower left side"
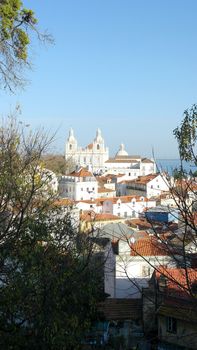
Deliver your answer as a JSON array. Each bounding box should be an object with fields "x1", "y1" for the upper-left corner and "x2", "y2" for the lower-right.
[{"x1": 0, "y1": 119, "x2": 103, "y2": 350}]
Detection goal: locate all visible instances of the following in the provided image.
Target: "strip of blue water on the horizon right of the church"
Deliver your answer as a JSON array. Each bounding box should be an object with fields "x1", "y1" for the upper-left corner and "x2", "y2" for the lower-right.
[{"x1": 156, "y1": 159, "x2": 197, "y2": 175}]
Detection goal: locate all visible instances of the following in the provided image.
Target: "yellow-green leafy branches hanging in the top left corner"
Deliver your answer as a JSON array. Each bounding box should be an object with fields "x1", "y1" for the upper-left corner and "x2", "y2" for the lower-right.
[{"x1": 0, "y1": 0, "x2": 51, "y2": 91}]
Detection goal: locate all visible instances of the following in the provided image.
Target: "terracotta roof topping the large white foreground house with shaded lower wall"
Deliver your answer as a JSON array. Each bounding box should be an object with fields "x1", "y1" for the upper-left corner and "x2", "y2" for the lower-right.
[{"x1": 130, "y1": 236, "x2": 171, "y2": 257}]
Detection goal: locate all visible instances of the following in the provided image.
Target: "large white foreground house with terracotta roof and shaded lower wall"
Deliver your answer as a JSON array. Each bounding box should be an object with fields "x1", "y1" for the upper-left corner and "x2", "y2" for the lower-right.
[{"x1": 115, "y1": 236, "x2": 175, "y2": 298}]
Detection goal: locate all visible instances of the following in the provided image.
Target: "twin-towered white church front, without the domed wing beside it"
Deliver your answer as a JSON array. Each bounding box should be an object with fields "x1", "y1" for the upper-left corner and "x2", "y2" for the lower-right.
[{"x1": 65, "y1": 129, "x2": 109, "y2": 173}]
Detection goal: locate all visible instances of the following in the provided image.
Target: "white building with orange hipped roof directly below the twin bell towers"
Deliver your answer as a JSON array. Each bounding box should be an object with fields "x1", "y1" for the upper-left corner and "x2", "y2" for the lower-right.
[{"x1": 59, "y1": 168, "x2": 98, "y2": 201}]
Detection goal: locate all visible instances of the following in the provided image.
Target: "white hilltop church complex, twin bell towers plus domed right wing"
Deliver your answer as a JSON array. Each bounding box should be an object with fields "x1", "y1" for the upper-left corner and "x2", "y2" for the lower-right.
[{"x1": 65, "y1": 129, "x2": 156, "y2": 176}]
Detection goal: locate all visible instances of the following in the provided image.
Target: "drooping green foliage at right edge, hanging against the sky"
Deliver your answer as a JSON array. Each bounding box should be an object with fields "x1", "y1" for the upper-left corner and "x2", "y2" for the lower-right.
[{"x1": 173, "y1": 105, "x2": 197, "y2": 164}]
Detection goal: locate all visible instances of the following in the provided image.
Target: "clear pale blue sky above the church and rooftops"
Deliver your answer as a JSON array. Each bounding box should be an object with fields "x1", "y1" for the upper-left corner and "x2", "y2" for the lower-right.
[{"x1": 0, "y1": 0, "x2": 197, "y2": 158}]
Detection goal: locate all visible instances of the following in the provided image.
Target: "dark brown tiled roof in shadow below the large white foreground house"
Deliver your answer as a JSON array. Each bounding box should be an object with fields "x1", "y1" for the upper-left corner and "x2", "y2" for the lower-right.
[{"x1": 98, "y1": 299, "x2": 142, "y2": 320}]
